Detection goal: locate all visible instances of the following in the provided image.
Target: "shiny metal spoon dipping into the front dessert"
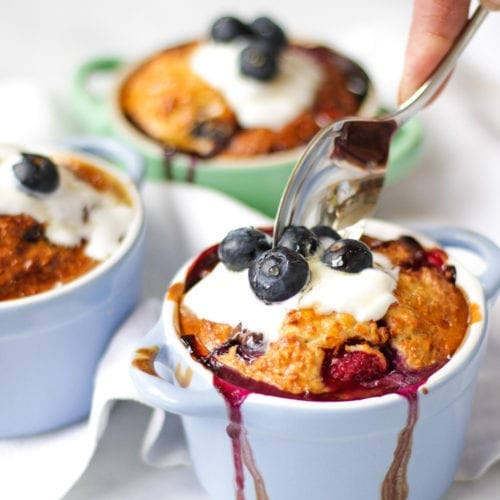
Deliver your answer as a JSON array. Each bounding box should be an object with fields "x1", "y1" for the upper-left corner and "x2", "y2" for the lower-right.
[{"x1": 274, "y1": 6, "x2": 488, "y2": 245}]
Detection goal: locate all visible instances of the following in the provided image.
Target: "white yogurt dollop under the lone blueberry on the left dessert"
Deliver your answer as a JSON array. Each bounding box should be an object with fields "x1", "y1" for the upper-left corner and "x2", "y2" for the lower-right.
[{"x1": 0, "y1": 155, "x2": 133, "y2": 260}]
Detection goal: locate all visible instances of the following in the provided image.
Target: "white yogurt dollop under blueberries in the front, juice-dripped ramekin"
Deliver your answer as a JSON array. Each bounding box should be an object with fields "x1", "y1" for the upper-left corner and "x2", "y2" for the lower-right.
[{"x1": 184, "y1": 253, "x2": 398, "y2": 341}]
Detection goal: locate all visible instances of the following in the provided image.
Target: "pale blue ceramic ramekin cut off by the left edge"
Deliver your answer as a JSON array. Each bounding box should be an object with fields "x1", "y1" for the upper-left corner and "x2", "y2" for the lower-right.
[{"x1": 0, "y1": 138, "x2": 144, "y2": 438}]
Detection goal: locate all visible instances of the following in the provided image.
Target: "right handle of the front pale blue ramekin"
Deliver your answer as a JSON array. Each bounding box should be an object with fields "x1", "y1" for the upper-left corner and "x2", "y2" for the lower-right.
[{"x1": 422, "y1": 227, "x2": 500, "y2": 302}]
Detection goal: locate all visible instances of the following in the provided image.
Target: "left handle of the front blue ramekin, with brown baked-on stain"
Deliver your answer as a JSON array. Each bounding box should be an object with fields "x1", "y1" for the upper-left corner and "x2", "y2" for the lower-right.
[{"x1": 130, "y1": 320, "x2": 226, "y2": 417}]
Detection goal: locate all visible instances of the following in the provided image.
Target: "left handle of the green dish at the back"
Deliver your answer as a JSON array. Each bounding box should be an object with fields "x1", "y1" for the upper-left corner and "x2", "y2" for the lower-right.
[{"x1": 70, "y1": 57, "x2": 125, "y2": 134}]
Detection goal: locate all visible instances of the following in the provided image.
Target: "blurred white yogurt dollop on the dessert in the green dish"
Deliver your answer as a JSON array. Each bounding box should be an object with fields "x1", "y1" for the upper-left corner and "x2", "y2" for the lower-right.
[{"x1": 191, "y1": 41, "x2": 323, "y2": 129}]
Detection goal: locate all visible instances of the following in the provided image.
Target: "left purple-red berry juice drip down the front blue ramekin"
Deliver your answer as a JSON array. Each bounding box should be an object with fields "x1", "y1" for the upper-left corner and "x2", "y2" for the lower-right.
[{"x1": 214, "y1": 375, "x2": 269, "y2": 500}]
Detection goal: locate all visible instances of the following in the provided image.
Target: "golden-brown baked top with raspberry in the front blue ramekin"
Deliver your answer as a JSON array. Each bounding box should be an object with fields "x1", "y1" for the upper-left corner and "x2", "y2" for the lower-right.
[{"x1": 171, "y1": 232, "x2": 471, "y2": 399}]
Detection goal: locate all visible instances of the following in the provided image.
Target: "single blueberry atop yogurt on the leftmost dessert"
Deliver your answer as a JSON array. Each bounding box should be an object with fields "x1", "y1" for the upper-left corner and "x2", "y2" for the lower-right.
[{"x1": 12, "y1": 153, "x2": 59, "y2": 194}]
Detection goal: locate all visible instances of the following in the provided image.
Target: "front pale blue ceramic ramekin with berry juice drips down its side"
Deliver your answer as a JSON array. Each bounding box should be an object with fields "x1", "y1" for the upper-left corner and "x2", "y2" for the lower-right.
[{"x1": 132, "y1": 221, "x2": 500, "y2": 500}]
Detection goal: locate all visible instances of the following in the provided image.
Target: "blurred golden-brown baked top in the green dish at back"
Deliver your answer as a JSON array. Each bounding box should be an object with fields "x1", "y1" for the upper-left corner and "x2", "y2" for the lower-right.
[{"x1": 119, "y1": 41, "x2": 362, "y2": 157}]
